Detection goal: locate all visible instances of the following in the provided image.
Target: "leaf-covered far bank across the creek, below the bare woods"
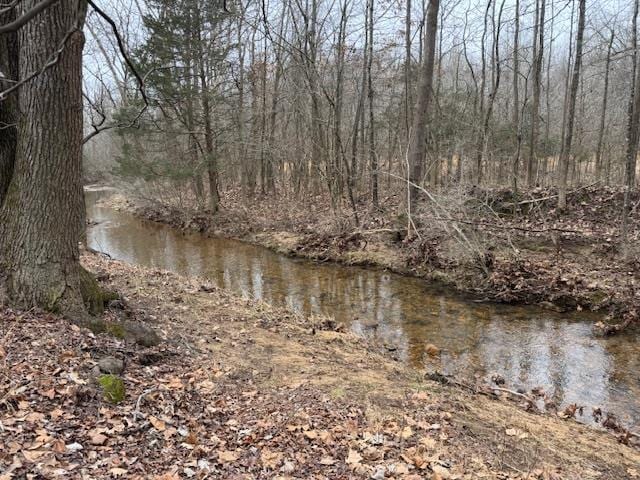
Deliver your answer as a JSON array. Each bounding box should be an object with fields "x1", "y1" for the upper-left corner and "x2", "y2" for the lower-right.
[{"x1": 102, "y1": 185, "x2": 640, "y2": 333}]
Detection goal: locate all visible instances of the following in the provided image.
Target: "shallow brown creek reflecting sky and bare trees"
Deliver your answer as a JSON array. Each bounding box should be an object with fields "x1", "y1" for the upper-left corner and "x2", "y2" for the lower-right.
[{"x1": 87, "y1": 191, "x2": 640, "y2": 430}]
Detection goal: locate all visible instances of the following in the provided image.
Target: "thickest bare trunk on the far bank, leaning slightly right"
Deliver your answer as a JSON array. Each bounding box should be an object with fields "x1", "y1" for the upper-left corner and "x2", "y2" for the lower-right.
[{"x1": 408, "y1": 0, "x2": 440, "y2": 207}]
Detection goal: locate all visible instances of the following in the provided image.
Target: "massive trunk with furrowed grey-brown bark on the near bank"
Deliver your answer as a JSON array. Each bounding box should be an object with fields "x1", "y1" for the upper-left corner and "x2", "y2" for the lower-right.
[{"x1": 0, "y1": 0, "x2": 86, "y2": 316}]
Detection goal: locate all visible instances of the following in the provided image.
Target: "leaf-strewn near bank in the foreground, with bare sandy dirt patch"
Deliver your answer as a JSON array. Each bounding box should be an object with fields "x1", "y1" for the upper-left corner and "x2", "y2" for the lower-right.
[{"x1": 0, "y1": 255, "x2": 640, "y2": 480}]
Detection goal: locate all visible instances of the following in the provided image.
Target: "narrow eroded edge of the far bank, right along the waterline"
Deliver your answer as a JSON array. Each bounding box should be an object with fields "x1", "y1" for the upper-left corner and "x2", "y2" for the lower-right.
[{"x1": 94, "y1": 189, "x2": 635, "y2": 328}]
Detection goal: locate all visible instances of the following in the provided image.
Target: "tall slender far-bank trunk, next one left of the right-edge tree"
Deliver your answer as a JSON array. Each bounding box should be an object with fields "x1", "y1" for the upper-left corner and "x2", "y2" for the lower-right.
[{"x1": 558, "y1": 0, "x2": 586, "y2": 210}]
